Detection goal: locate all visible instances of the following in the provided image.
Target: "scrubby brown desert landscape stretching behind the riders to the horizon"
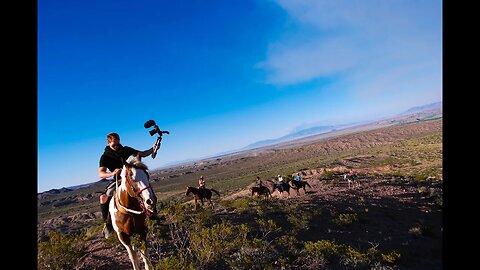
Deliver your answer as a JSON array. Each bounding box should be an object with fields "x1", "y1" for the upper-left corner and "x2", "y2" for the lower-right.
[{"x1": 37, "y1": 115, "x2": 443, "y2": 269}]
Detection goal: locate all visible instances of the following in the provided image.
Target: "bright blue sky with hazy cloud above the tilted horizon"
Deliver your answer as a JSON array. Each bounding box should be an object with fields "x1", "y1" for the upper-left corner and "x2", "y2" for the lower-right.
[{"x1": 37, "y1": 0, "x2": 442, "y2": 192}]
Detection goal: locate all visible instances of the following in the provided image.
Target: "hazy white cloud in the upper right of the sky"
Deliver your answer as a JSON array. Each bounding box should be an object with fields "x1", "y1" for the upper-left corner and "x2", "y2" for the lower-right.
[{"x1": 259, "y1": 0, "x2": 441, "y2": 92}]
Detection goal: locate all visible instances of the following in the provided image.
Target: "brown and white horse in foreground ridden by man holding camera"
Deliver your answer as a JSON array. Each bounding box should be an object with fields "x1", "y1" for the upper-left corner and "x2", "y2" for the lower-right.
[{"x1": 109, "y1": 156, "x2": 157, "y2": 270}]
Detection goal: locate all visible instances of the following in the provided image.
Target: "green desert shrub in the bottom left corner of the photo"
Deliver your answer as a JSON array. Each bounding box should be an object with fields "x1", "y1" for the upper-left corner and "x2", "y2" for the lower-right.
[{"x1": 37, "y1": 231, "x2": 86, "y2": 269}]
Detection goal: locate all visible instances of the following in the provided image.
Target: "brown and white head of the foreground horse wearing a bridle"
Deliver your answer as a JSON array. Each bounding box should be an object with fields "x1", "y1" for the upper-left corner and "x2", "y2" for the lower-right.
[{"x1": 121, "y1": 158, "x2": 157, "y2": 215}]
